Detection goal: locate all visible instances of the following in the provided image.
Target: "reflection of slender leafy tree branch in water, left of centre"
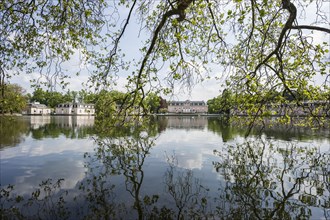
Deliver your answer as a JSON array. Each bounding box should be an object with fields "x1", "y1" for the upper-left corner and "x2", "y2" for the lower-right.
[{"x1": 82, "y1": 133, "x2": 153, "y2": 219}]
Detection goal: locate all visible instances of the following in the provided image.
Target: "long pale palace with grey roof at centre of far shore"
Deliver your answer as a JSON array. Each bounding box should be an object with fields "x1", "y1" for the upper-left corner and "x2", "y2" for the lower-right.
[{"x1": 168, "y1": 100, "x2": 207, "y2": 113}]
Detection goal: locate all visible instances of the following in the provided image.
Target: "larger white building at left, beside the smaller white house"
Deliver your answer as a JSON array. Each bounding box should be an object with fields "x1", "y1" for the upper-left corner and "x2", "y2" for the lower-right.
[{"x1": 55, "y1": 103, "x2": 95, "y2": 115}]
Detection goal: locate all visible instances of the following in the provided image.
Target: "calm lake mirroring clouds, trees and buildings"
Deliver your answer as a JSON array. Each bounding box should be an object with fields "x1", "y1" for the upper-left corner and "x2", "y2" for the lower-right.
[{"x1": 0, "y1": 116, "x2": 330, "y2": 219}]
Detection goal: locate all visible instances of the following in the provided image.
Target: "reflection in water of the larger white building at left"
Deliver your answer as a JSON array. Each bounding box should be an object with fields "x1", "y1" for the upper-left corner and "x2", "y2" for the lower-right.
[{"x1": 54, "y1": 115, "x2": 94, "y2": 128}]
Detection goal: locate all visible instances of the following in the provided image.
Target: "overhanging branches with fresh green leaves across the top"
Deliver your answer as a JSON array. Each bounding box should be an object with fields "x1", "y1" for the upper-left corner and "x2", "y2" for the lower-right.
[{"x1": 0, "y1": 0, "x2": 330, "y2": 124}]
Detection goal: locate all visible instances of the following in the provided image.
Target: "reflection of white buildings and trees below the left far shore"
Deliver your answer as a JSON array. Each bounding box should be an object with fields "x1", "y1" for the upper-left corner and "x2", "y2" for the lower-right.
[{"x1": 0, "y1": 116, "x2": 95, "y2": 149}]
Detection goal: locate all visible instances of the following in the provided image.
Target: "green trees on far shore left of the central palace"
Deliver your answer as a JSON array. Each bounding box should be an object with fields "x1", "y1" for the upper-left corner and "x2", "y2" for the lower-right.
[{"x1": 0, "y1": 84, "x2": 167, "y2": 114}]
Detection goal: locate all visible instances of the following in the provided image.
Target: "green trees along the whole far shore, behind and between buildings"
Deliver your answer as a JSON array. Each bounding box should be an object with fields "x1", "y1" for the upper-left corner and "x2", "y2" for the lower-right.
[{"x1": 0, "y1": 84, "x2": 330, "y2": 114}]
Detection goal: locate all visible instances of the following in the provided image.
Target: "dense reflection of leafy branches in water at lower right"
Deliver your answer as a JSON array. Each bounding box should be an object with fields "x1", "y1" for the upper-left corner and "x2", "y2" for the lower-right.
[{"x1": 214, "y1": 139, "x2": 330, "y2": 219}]
